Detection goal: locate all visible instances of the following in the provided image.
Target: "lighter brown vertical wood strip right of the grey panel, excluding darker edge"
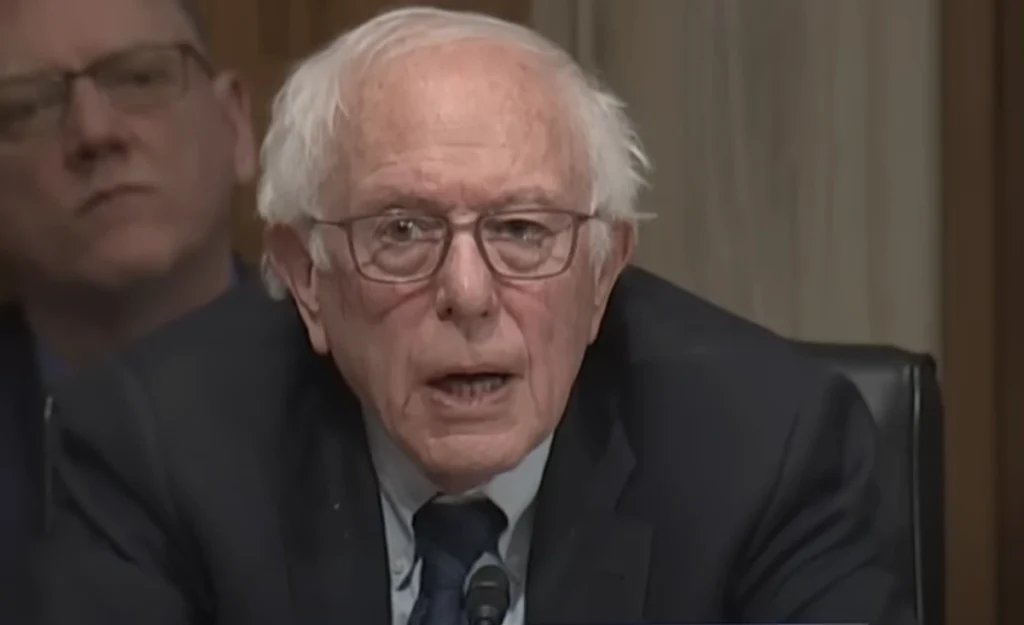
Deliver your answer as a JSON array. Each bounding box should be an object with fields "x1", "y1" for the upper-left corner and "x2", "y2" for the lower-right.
[{"x1": 941, "y1": 0, "x2": 998, "y2": 625}]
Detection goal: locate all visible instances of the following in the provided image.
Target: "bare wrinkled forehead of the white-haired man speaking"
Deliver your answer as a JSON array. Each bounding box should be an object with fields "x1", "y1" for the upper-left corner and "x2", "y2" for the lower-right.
[{"x1": 351, "y1": 42, "x2": 578, "y2": 194}]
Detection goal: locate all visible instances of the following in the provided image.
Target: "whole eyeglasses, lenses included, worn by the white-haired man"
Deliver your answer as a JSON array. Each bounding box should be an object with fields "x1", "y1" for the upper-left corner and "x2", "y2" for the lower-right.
[{"x1": 314, "y1": 209, "x2": 594, "y2": 284}]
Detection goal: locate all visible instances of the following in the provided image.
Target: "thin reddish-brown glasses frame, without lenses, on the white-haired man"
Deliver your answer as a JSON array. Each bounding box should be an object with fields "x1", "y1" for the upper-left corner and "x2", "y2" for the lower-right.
[{"x1": 311, "y1": 208, "x2": 598, "y2": 284}]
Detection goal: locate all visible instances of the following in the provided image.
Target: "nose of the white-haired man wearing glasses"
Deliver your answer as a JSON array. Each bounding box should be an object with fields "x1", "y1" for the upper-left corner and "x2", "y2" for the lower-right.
[{"x1": 437, "y1": 233, "x2": 498, "y2": 324}]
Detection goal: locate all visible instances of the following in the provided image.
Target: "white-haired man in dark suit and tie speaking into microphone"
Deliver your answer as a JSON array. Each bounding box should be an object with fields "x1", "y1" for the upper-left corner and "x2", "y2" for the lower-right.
[{"x1": 29, "y1": 8, "x2": 912, "y2": 625}]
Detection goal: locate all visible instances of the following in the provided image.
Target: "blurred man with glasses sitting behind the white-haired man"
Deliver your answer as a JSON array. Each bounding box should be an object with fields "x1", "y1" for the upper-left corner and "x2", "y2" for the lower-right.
[{"x1": 0, "y1": 0, "x2": 255, "y2": 602}]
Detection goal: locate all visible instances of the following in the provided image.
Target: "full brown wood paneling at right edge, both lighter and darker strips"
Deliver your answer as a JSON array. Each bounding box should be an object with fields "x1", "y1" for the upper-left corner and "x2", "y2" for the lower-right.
[{"x1": 942, "y1": 0, "x2": 1024, "y2": 625}]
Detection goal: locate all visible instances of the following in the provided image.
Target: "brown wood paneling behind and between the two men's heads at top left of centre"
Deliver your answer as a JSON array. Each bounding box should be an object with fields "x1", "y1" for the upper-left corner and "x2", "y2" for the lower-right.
[{"x1": 197, "y1": 0, "x2": 529, "y2": 259}]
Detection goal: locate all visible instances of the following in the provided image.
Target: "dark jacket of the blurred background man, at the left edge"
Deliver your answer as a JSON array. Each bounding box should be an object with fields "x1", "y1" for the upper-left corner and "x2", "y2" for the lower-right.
[{"x1": 0, "y1": 305, "x2": 45, "y2": 606}]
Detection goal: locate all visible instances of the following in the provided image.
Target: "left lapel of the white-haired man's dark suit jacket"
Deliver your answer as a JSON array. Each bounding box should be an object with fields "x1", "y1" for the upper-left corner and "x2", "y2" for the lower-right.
[{"x1": 282, "y1": 354, "x2": 391, "y2": 625}]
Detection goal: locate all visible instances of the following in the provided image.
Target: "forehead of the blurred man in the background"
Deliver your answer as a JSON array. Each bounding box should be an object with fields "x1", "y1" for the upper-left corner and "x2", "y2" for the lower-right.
[{"x1": 0, "y1": 0, "x2": 194, "y2": 74}]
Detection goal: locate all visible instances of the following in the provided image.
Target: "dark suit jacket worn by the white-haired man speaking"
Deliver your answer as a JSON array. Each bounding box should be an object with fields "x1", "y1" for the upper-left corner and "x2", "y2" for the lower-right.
[{"x1": 29, "y1": 269, "x2": 912, "y2": 625}]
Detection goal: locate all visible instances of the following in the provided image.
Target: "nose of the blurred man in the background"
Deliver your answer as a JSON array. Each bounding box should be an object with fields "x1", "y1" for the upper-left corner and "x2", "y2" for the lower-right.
[{"x1": 63, "y1": 79, "x2": 127, "y2": 168}]
